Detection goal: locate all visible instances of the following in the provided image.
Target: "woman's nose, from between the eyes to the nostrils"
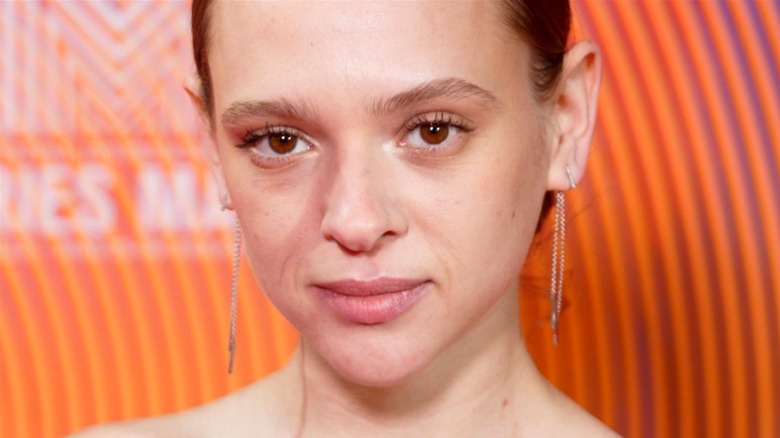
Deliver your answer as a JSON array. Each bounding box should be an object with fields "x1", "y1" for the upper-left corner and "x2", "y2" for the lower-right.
[{"x1": 322, "y1": 148, "x2": 408, "y2": 253}]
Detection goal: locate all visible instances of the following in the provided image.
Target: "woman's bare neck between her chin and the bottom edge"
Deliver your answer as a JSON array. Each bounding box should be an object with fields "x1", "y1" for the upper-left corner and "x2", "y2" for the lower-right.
[{"x1": 290, "y1": 295, "x2": 546, "y2": 436}]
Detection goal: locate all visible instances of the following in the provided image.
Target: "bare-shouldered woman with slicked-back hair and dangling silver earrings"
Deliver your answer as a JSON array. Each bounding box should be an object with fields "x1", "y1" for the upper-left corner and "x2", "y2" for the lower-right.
[{"x1": 77, "y1": 0, "x2": 612, "y2": 437}]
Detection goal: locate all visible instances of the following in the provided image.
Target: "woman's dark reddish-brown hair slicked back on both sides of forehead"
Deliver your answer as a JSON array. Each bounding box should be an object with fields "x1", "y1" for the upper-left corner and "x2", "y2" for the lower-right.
[{"x1": 192, "y1": 0, "x2": 571, "y2": 118}]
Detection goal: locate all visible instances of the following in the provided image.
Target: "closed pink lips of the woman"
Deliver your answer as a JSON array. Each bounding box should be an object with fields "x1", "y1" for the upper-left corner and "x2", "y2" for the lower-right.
[{"x1": 314, "y1": 278, "x2": 429, "y2": 324}]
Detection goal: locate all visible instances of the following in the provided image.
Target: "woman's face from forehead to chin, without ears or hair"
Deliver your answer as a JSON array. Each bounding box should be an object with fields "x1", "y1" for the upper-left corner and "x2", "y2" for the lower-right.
[{"x1": 208, "y1": 2, "x2": 549, "y2": 386}]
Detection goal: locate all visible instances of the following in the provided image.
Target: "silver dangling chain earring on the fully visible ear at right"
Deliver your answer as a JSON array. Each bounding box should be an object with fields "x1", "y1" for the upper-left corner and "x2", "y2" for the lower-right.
[{"x1": 550, "y1": 164, "x2": 577, "y2": 345}]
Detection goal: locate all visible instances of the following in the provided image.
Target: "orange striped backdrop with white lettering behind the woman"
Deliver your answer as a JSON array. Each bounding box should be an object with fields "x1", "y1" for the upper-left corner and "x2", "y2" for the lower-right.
[{"x1": 0, "y1": 1, "x2": 780, "y2": 437}]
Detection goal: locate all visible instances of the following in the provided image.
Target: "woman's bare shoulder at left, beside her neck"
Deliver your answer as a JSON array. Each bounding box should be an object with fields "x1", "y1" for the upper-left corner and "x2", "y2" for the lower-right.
[{"x1": 71, "y1": 368, "x2": 293, "y2": 438}]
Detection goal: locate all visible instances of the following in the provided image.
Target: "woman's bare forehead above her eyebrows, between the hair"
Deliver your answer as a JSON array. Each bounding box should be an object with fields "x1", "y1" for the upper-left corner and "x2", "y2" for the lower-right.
[{"x1": 208, "y1": 1, "x2": 527, "y2": 114}]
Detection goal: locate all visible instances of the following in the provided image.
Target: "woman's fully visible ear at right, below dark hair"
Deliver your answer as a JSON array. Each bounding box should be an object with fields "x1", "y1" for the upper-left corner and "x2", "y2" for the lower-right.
[{"x1": 547, "y1": 40, "x2": 601, "y2": 191}]
